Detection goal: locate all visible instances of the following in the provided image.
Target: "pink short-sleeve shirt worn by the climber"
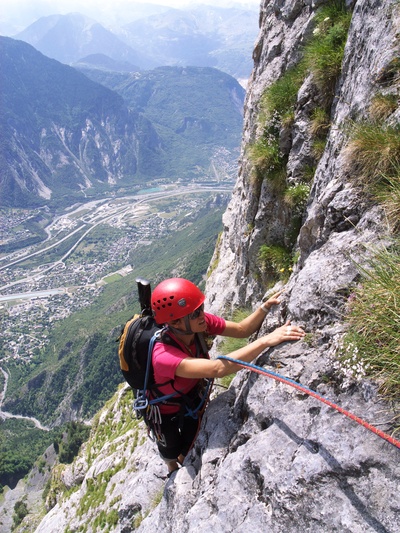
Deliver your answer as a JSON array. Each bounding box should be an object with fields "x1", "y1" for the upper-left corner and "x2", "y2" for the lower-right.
[{"x1": 152, "y1": 313, "x2": 226, "y2": 414}]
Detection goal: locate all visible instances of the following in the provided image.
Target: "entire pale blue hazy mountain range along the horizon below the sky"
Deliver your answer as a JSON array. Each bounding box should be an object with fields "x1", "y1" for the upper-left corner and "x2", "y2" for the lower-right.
[{"x1": 15, "y1": 5, "x2": 258, "y2": 80}]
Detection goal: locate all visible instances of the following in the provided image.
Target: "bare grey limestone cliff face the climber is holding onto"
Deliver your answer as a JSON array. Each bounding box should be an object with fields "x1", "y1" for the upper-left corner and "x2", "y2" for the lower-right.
[{"x1": 27, "y1": 0, "x2": 400, "y2": 533}]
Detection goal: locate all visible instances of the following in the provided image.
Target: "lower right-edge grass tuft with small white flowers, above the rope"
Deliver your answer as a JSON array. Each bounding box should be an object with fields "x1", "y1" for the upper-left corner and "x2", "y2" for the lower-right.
[{"x1": 341, "y1": 242, "x2": 400, "y2": 408}]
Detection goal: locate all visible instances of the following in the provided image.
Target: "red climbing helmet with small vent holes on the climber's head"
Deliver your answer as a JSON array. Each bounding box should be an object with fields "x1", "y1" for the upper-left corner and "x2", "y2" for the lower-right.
[{"x1": 151, "y1": 278, "x2": 206, "y2": 324}]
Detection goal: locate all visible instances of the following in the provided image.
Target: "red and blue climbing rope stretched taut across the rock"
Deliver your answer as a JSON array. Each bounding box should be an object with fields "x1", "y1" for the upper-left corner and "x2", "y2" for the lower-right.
[{"x1": 217, "y1": 355, "x2": 400, "y2": 449}]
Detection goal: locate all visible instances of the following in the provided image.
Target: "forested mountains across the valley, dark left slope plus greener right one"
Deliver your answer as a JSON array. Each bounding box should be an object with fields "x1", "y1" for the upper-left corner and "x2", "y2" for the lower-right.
[{"x1": 0, "y1": 37, "x2": 244, "y2": 206}]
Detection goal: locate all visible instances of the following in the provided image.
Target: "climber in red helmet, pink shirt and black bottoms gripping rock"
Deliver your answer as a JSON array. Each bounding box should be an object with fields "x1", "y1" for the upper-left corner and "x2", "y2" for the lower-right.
[{"x1": 151, "y1": 278, "x2": 305, "y2": 476}]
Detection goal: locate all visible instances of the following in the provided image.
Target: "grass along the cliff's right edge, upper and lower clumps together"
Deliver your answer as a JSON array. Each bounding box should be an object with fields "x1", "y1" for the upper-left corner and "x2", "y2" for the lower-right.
[{"x1": 342, "y1": 88, "x2": 400, "y2": 408}]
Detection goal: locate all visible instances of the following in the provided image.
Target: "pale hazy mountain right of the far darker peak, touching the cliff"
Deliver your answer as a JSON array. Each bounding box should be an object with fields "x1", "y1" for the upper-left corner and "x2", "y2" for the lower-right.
[{"x1": 121, "y1": 5, "x2": 258, "y2": 80}]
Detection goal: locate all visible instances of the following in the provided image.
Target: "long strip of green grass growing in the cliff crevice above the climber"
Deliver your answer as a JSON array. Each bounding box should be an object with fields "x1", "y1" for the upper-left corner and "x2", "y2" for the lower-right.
[{"x1": 247, "y1": 0, "x2": 351, "y2": 285}]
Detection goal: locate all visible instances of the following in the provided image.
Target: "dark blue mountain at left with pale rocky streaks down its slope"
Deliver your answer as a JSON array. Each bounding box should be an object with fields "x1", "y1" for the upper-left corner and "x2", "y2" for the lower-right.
[{"x1": 0, "y1": 37, "x2": 147, "y2": 206}]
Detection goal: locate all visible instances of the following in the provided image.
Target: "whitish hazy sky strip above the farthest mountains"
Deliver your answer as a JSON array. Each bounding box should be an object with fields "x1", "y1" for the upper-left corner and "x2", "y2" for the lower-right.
[{"x1": 0, "y1": 0, "x2": 260, "y2": 35}]
